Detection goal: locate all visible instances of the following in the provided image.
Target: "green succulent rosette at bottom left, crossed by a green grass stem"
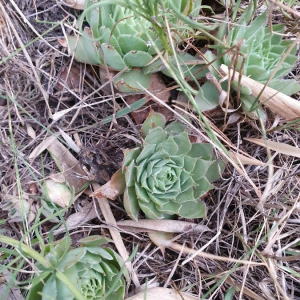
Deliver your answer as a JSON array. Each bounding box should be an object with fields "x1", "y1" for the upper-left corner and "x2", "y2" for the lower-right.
[{"x1": 27, "y1": 236, "x2": 125, "y2": 300}]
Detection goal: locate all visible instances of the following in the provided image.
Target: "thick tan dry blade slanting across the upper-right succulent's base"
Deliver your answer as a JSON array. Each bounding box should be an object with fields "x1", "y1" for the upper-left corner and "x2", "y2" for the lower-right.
[{"x1": 220, "y1": 65, "x2": 300, "y2": 120}]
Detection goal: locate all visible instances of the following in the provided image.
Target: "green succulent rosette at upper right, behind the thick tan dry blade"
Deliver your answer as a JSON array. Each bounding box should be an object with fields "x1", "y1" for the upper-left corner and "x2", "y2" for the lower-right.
[{"x1": 199, "y1": 9, "x2": 300, "y2": 116}]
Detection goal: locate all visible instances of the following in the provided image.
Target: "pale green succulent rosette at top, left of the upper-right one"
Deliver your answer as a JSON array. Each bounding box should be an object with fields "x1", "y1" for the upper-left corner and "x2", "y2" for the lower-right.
[{"x1": 68, "y1": 1, "x2": 162, "y2": 92}]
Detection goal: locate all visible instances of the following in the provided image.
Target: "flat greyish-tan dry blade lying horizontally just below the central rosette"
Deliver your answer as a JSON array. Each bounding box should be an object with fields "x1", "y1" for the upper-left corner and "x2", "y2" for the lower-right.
[{"x1": 117, "y1": 219, "x2": 212, "y2": 233}]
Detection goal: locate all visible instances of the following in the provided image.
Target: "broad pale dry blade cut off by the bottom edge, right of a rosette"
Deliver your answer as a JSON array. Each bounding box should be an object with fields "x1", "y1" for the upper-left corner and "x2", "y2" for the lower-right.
[{"x1": 126, "y1": 287, "x2": 198, "y2": 300}]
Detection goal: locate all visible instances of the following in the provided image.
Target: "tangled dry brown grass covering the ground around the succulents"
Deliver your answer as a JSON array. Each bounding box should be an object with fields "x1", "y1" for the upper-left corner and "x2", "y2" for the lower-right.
[{"x1": 0, "y1": 0, "x2": 300, "y2": 300}]
